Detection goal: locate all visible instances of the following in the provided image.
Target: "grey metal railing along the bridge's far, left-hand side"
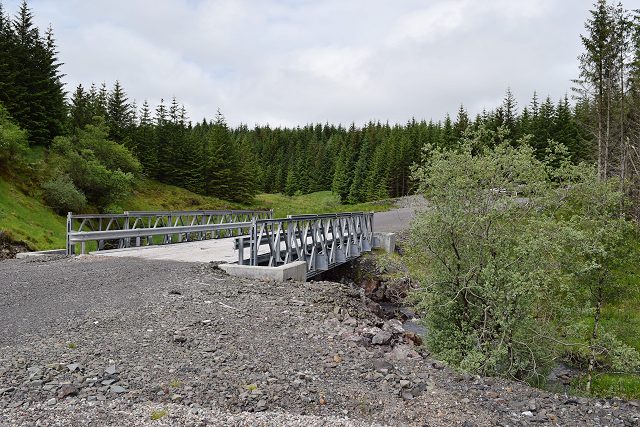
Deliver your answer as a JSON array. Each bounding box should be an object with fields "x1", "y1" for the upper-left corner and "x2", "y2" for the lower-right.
[{"x1": 67, "y1": 210, "x2": 273, "y2": 255}]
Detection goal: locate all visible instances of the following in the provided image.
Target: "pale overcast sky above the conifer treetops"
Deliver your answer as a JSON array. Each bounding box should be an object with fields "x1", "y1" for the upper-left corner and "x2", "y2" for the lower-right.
[{"x1": 6, "y1": 0, "x2": 604, "y2": 126}]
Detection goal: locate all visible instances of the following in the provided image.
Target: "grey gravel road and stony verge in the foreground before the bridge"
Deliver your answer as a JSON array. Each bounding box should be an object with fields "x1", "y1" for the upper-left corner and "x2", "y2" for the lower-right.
[{"x1": 0, "y1": 256, "x2": 640, "y2": 427}]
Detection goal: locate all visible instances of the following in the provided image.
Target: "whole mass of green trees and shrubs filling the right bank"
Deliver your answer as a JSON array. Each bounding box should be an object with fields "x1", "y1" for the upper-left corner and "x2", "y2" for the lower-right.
[{"x1": 410, "y1": 131, "x2": 640, "y2": 398}]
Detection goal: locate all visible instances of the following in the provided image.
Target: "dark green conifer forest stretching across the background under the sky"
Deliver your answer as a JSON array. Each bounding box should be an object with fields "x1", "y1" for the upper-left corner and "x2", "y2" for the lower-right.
[{"x1": 0, "y1": 0, "x2": 640, "y2": 219}]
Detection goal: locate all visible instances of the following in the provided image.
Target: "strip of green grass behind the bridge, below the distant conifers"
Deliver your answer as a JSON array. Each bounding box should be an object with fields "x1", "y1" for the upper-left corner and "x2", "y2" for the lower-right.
[{"x1": 250, "y1": 191, "x2": 393, "y2": 218}]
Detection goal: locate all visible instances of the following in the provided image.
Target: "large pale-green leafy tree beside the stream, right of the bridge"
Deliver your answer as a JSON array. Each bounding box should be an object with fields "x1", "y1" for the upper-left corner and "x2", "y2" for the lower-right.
[{"x1": 412, "y1": 140, "x2": 557, "y2": 378}]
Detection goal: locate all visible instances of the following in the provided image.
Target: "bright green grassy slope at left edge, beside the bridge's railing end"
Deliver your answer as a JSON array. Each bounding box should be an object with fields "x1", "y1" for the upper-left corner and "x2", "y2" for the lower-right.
[{"x1": 0, "y1": 178, "x2": 66, "y2": 250}]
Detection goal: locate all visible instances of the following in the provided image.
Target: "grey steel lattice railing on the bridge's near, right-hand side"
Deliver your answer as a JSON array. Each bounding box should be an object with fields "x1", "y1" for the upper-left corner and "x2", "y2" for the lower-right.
[{"x1": 245, "y1": 212, "x2": 373, "y2": 277}]
